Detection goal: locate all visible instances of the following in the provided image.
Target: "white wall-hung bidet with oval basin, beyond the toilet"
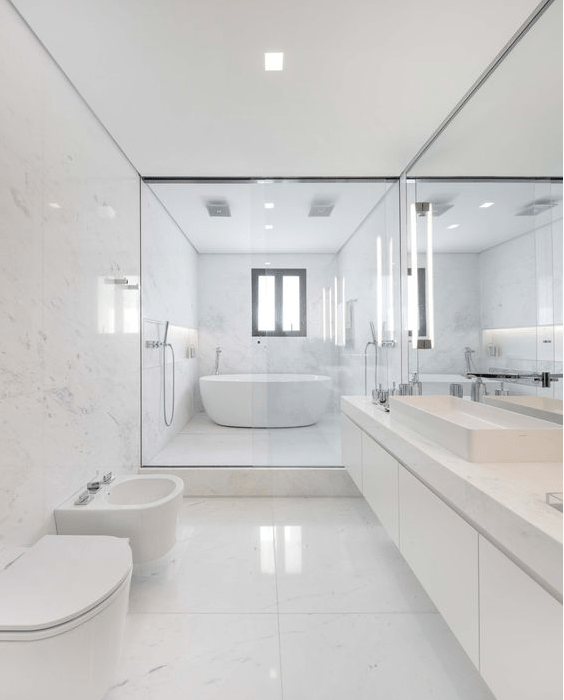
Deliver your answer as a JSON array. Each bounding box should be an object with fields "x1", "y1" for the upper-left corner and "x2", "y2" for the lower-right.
[{"x1": 55, "y1": 474, "x2": 184, "y2": 563}]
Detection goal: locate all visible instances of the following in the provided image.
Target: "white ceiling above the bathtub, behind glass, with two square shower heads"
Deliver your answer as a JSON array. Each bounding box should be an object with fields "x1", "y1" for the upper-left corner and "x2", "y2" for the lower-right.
[{"x1": 150, "y1": 181, "x2": 389, "y2": 254}]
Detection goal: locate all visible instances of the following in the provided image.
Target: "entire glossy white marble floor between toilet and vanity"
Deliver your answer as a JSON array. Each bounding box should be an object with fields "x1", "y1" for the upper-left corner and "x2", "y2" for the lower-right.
[{"x1": 104, "y1": 497, "x2": 493, "y2": 700}]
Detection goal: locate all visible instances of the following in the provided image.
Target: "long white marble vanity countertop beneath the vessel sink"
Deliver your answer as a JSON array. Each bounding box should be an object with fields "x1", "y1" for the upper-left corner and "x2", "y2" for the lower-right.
[{"x1": 341, "y1": 396, "x2": 563, "y2": 601}]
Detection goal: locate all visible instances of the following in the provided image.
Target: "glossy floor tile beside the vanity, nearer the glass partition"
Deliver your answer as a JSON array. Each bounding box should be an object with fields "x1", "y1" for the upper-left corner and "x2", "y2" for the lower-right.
[{"x1": 274, "y1": 498, "x2": 435, "y2": 613}]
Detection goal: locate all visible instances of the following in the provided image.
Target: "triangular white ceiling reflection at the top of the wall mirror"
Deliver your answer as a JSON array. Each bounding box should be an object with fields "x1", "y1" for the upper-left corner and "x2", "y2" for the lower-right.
[{"x1": 412, "y1": 0, "x2": 563, "y2": 177}]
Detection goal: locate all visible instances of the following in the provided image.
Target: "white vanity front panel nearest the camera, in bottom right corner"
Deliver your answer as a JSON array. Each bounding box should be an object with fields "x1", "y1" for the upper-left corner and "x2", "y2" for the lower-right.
[{"x1": 479, "y1": 536, "x2": 562, "y2": 700}]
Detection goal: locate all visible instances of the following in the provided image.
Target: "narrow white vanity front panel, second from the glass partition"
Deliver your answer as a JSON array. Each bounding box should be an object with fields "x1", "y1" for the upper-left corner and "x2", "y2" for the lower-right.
[{"x1": 362, "y1": 432, "x2": 399, "y2": 547}]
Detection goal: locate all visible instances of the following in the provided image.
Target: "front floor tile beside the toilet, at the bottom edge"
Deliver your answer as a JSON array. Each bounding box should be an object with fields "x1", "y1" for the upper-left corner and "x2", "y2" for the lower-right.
[{"x1": 104, "y1": 614, "x2": 282, "y2": 700}]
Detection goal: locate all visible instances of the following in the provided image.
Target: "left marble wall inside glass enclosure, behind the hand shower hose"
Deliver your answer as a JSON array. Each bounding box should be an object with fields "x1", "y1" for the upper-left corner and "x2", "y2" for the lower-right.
[{"x1": 141, "y1": 183, "x2": 199, "y2": 464}]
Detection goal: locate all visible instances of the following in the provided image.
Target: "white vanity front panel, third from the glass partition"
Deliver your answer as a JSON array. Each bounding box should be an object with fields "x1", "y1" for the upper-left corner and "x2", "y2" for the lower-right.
[{"x1": 399, "y1": 467, "x2": 479, "y2": 666}]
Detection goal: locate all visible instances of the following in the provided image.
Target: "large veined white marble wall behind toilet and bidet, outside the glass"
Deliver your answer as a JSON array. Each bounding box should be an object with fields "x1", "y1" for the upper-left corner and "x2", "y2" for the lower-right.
[{"x1": 0, "y1": 0, "x2": 140, "y2": 545}]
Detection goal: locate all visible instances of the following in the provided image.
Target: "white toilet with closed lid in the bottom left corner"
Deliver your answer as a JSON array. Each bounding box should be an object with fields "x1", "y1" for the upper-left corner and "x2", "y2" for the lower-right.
[{"x1": 0, "y1": 535, "x2": 132, "y2": 700}]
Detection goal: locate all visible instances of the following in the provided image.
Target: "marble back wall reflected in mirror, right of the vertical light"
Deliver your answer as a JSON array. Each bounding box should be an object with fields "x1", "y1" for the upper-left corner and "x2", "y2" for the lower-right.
[{"x1": 409, "y1": 253, "x2": 480, "y2": 374}]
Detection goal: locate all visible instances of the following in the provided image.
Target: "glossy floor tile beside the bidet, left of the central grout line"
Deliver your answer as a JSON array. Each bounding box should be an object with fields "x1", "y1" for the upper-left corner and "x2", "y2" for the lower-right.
[{"x1": 130, "y1": 498, "x2": 277, "y2": 613}]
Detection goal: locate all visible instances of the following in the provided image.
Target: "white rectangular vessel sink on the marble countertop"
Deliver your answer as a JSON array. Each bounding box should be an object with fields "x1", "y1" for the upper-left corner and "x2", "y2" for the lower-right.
[{"x1": 390, "y1": 396, "x2": 562, "y2": 462}]
